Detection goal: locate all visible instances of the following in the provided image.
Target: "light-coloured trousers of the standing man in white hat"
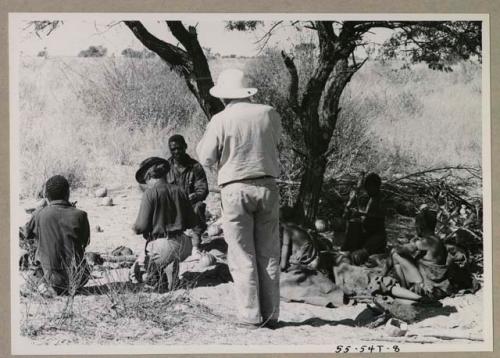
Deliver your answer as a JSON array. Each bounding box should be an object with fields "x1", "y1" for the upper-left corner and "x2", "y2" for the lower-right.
[{"x1": 221, "y1": 178, "x2": 280, "y2": 324}]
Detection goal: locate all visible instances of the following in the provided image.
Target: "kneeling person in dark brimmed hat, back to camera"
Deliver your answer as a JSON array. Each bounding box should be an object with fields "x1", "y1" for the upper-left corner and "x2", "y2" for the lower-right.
[{"x1": 130, "y1": 157, "x2": 197, "y2": 290}]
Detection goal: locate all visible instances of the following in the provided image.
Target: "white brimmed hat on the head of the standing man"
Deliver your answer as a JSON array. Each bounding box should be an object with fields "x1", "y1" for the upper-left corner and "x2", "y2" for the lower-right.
[{"x1": 210, "y1": 68, "x2": 257, "y2": 105}]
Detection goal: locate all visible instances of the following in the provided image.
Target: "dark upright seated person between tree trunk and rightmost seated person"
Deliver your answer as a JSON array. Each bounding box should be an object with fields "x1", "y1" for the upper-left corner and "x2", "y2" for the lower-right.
[{"x1": 342, "y1": 173, "x2": 387, "y2": 265}]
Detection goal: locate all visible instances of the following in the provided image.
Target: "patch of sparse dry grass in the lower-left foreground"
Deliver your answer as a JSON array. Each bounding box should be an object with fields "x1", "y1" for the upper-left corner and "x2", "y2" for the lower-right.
[{"x1": 21, "y1": 262, "x2": 223, "y2": 344}]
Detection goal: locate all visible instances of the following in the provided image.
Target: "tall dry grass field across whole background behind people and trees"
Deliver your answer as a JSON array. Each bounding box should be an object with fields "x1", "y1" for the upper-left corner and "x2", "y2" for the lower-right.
[{"x1": 19, "y1": 55, "x2": 481, "y2": 196}]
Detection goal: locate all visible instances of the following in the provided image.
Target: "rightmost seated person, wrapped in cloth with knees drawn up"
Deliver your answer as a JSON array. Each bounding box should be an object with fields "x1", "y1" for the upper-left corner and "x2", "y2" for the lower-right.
[{"x1": 388, "y1": 206, "x2": 450, "y2": 300}]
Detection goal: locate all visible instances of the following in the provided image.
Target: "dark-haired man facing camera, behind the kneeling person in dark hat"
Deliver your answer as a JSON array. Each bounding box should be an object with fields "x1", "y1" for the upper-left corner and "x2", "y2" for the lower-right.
[{"x1": 167, "y1": 134, "x2": 208, "y2": 257}]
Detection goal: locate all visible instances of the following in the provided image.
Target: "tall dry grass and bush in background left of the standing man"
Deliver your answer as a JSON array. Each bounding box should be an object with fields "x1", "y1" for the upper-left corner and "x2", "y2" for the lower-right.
[{"x1": 19, "y1": 57, "x2": 206, "y2": 196}]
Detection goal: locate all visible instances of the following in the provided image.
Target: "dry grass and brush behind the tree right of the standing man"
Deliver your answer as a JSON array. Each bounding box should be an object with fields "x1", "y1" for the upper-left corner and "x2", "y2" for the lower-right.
[{"x1": 248, "y1": 50, "x2": 481, "y2": 179}]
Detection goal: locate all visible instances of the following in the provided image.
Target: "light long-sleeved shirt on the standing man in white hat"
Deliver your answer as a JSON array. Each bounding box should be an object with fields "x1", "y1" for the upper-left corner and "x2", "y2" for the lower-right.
[{"x1": 196, "y1": 100, "x2": 282, "y2": 185}]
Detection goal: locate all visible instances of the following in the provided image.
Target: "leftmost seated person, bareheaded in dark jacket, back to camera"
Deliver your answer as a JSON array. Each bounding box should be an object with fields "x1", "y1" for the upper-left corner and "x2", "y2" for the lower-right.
[{"x1": 25, "y1": 175, "x2": 90, "y2": 296}]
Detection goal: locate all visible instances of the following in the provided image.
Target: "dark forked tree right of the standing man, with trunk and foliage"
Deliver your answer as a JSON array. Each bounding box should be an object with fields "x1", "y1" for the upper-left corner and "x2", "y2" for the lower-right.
[{"x1": 227, "y1": 21, "x2": 481, "y2": 224}]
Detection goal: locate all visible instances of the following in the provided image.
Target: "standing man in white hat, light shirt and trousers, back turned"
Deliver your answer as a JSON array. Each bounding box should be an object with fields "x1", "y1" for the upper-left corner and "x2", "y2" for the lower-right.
[{"x1": 197, "y1": 69, "x2": 282, "y2": 328}]
